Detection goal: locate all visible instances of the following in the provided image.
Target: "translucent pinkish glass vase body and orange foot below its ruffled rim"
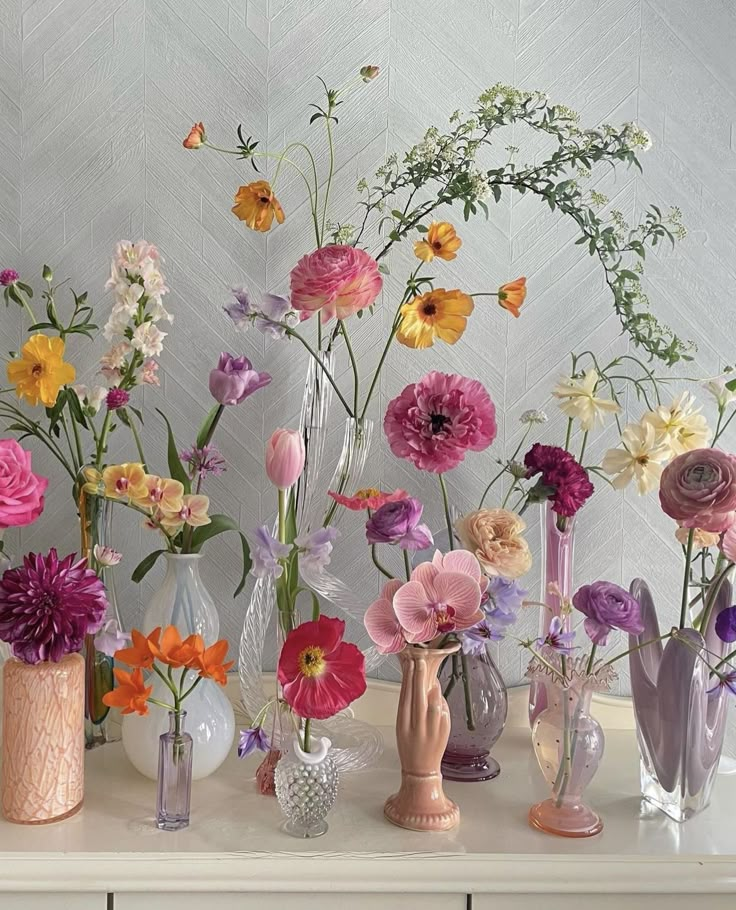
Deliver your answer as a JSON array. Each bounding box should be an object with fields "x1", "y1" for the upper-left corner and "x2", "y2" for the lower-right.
[{"x1": 529, "y1": 680, "x2": 605, "y2": 837}]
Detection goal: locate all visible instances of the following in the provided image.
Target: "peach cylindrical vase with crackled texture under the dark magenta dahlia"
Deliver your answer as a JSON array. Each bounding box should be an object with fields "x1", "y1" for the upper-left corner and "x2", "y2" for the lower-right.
[{"x1": 2, "y1": 654, "x2": 84, "y2": 825}]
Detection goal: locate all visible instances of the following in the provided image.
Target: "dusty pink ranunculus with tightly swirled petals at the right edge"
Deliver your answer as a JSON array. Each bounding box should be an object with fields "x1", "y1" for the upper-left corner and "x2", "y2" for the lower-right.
[{"x1": 659, "y1": 449, "x2": 736, "y2": 533}]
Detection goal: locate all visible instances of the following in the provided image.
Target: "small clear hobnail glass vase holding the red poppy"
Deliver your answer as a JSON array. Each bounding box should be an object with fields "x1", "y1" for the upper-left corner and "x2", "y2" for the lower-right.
[{"x1": 275, "y1": 736, "x2": 339, "y2": 838}]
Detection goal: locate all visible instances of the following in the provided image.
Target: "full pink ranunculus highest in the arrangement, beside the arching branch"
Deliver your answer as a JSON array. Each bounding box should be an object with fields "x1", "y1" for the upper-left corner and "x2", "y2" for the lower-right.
[{"x1": 291, "y1": 245, "x2": 383, "y2": 322}]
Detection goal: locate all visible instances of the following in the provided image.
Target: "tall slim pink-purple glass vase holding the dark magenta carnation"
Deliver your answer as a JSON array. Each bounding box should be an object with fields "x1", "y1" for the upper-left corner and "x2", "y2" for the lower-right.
[{"x1": 529, "y1": 501, "x2": 575, "y2": 727}]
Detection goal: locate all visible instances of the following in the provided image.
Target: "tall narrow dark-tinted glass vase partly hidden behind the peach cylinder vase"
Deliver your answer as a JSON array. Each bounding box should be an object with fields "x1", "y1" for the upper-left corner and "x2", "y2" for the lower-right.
[{"x1": 79, "y1": 493, "x2": 123, "y2": 749}]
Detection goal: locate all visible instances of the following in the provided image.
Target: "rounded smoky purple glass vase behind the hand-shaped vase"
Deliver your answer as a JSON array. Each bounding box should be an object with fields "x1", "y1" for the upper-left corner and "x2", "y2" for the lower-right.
[{"x1": 440, "y1": 648, "x2": 508, "y2": 781}]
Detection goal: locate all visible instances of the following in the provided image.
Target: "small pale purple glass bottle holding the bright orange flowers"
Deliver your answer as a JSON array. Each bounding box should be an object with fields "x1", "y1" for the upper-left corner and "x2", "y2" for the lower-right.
[{"x1": 156, "y1": 711, "x2": 194, "y2": 831}]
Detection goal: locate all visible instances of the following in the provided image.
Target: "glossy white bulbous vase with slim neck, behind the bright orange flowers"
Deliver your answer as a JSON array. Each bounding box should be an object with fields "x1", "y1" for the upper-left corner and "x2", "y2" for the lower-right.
[{"x1": 123, "y1": 553, "x2": 235, "y2": 780}]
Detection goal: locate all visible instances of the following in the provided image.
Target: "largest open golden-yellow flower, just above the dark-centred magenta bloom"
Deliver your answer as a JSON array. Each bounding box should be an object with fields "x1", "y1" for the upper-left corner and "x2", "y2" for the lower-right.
[{"x1": 396, "y1": 288, "x2": 473, "y2": 349}]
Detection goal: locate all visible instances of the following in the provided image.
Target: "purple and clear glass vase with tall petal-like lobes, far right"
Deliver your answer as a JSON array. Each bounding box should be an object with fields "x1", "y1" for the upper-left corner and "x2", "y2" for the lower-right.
[{"x1": 629, "y1": 578, "x2": 731, "y2": 822}]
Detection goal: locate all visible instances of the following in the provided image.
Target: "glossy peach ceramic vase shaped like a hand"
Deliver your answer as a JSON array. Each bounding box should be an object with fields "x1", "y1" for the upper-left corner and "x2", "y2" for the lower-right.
[{"x1": 383, "y1": 644, "x2": 460, "y2": 831}]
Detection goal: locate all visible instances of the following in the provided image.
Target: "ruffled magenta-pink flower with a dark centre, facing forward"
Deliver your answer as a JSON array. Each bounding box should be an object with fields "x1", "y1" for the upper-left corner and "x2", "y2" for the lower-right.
[{"x1": 383, "y1": 371, "x2": 496, "y2": 474}]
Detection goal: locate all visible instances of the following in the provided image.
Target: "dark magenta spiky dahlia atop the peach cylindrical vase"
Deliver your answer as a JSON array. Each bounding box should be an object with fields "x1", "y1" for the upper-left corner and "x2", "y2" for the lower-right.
[{"x1": 0, "y1": 547, "x2": 107, "y2": 664}]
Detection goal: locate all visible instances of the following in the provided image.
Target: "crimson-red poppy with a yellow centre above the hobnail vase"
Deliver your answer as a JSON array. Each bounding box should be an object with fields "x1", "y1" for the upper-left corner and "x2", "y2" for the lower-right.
[{"x1": 278, "y1": 616, "x2": 365, "y2": 720}]
